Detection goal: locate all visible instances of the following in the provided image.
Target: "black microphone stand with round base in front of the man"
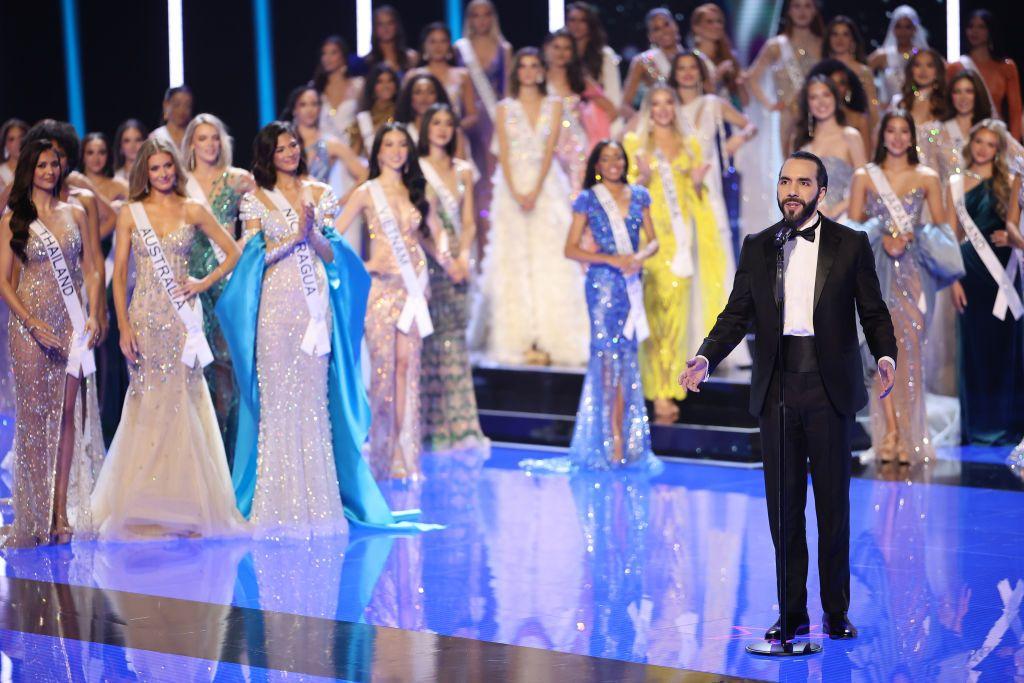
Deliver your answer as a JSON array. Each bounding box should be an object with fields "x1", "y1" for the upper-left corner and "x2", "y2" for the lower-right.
[{"x1": 746, "y1": 224, "x2": 821, "y2": 656}]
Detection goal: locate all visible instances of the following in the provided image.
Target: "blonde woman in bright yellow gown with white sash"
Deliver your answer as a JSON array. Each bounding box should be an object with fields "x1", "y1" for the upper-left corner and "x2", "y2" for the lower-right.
[{"x1": 624, "y1": 85, "x2": 729, "y2": 419}]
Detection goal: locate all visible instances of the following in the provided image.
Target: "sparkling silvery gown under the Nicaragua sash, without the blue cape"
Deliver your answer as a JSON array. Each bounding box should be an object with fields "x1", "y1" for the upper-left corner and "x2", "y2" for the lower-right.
[{"x1": 241, "y1": 189, "x2": 348, "y2": 538}]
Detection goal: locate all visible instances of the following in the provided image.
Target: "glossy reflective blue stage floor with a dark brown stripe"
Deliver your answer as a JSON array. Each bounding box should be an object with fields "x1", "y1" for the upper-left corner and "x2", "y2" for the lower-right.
[{"x1": 0, "y1": 440, "x2": 1024, "y2": 683}]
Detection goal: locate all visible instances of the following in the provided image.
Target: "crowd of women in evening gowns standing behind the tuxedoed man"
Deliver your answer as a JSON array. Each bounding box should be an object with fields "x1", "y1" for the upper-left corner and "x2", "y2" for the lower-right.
[{"x1": 0, "y1": 0, "x2": 1024, "y2": 545}]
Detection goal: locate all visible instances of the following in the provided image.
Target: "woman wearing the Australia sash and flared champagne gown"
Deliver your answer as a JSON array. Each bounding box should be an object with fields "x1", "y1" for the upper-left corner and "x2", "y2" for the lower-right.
[{"x1": 92, "y1": 138, "x2": 245, "y2": 541}]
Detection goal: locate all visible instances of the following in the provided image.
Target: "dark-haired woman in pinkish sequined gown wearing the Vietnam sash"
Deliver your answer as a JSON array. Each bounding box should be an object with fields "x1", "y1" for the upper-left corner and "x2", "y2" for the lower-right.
[{"x1": 336, "y1": 123, "x2": 434, "y2": 480}]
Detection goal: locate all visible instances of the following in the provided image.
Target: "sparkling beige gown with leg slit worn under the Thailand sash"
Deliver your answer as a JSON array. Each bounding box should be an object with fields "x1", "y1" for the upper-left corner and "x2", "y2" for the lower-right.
[{"x1": 3, "y1": 212, "x2": 103, "y2": 547}]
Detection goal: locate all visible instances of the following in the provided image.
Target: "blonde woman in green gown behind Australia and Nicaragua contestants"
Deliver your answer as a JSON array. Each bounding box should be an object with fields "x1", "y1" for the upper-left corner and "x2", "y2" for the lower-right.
[{"x1": 182, "y1": 114, "x2": 256, "y2": 465}]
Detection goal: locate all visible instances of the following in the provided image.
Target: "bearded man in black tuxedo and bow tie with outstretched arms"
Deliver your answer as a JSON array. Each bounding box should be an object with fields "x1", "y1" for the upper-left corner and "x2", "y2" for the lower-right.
[{"x1": 679, "y1": 152, "x2": 897, "y2": 640}]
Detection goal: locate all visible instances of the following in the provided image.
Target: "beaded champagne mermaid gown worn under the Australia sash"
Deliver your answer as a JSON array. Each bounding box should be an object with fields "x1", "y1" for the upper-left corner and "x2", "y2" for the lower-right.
[{"x1": 92, "y1": 210, "x2": 246, "y2": 541}]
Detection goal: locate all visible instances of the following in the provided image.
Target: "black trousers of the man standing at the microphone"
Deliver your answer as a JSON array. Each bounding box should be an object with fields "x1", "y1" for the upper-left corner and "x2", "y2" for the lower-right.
[{"x1": 760, "y1": 339, "x2": 853, "y2": 614}]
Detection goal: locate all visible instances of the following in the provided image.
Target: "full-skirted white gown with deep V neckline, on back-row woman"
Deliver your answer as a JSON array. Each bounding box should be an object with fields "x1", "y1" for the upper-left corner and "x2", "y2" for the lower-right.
[{"x1": 481, "y1": 98, "x2": 587, "y2": 366}]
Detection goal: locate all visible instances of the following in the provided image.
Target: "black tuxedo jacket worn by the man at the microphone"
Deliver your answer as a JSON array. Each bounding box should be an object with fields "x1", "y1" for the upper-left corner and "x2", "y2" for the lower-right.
[{"x1": 697, "y1": 216, "x2": 897, "y2": 416}]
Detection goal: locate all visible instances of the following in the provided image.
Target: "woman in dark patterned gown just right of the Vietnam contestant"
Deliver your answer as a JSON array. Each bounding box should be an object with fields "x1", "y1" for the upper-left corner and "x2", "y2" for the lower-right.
[{"x1": 419, "y1": 104, "x2": 486, "y2": 451}]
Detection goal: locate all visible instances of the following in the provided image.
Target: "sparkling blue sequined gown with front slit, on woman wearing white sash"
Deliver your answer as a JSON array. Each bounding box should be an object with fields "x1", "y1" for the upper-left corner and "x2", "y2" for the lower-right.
[{"x1": 569, "y1": 185, "x2": 659, "y2": 470}]
